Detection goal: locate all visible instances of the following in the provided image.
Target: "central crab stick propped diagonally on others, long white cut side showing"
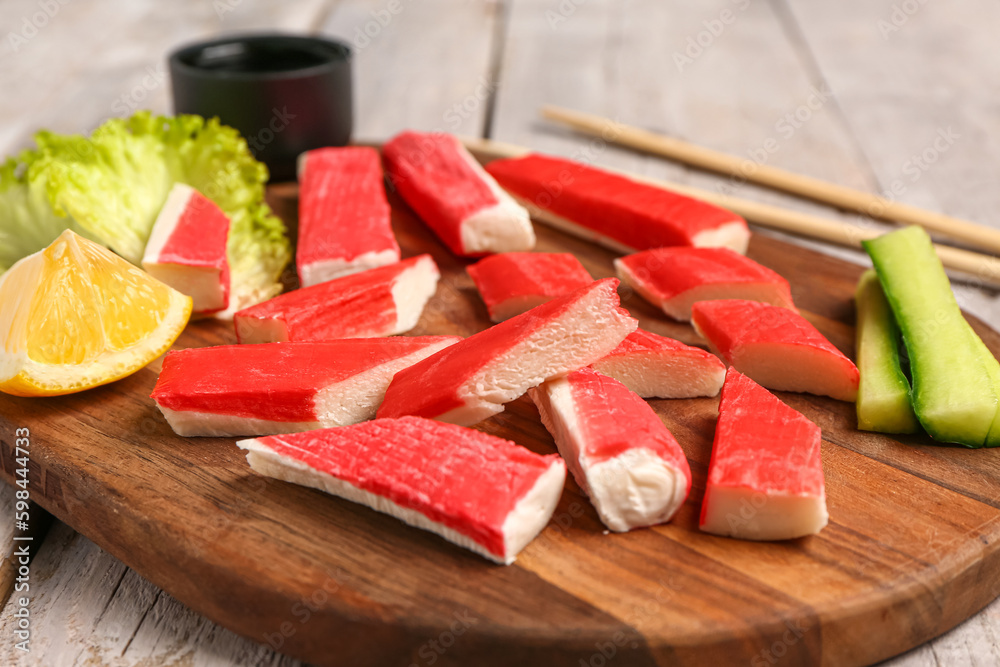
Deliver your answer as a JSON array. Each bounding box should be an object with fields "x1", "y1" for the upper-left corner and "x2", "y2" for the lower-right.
[{"x1": 378, "y1": 278, "x2": 638, "y2": 426}]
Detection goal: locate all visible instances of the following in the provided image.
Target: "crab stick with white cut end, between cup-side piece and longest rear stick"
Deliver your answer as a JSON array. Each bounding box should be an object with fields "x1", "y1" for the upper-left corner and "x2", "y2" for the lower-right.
[{"x1": 382, "y1": 131, "x2": 535, "y2": 257}]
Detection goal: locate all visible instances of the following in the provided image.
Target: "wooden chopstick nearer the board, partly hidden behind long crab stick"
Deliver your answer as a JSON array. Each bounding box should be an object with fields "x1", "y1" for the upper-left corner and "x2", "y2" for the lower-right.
[{"x1": 462, "y1": 138, "x2": 1000, "y2": 287}]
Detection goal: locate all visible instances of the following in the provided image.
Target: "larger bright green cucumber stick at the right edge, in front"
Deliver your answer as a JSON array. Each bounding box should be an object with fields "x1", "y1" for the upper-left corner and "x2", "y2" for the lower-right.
[{"x1": 864, "y1": 227, "x2": 998, "y2": 447}]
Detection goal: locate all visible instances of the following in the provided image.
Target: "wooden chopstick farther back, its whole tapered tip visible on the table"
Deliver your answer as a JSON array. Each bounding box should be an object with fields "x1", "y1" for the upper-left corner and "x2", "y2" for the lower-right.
[{"x1": 542, "y1": 105, "x2": 1000, "y2": 252}]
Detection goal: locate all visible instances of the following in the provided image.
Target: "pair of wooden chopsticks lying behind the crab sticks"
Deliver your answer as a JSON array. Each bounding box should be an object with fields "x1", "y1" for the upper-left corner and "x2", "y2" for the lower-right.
[{"x1": 542, "y1": 105, "x2": 1000, "y2": 286}]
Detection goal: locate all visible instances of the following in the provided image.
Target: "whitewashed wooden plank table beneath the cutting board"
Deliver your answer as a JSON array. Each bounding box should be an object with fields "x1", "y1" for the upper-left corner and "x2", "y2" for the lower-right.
[{"x1": 0, "y1": 0, "x2": 1000, "y2": 667}]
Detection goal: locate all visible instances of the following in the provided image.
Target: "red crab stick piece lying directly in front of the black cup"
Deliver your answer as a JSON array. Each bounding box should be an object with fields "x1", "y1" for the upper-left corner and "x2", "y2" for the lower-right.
[{"x1": 295, "y1": 146, "x2": 399, "y2": 287}]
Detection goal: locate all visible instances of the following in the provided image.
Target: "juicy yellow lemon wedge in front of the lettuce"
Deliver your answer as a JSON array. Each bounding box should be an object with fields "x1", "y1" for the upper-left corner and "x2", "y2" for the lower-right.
[{"x1": 0, "y1": 230, "x2": 191, "y2": 396}]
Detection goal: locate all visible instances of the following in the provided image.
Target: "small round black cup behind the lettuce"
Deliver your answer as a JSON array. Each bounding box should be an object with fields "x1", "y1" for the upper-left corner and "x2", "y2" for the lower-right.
[{"x1": 169, "y1": 34, "x2": 353, "y2": 182}]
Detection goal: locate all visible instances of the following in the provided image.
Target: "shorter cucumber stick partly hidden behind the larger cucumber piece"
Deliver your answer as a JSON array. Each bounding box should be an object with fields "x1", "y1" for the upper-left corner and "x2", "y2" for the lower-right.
[{"x1": 854, "y1": 270, "x2": 920, "y2": 433}]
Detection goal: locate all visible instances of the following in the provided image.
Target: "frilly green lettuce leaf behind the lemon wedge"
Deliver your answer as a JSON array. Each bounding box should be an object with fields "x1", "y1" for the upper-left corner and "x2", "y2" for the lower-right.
[{"x1": 0, "y1": 111, "x2": 291, "y2": 313}]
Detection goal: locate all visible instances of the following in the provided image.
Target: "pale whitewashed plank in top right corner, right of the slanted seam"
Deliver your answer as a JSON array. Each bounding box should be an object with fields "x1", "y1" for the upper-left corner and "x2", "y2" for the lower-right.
[{"x1": 788, "y1": 0, "x2": 1000, "y2": 340}]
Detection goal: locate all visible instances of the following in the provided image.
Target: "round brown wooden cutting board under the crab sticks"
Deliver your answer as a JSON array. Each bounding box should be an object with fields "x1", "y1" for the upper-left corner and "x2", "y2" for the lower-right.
[{"x1": 0, "y1": 151, "x2": 1000, "y2": 667}]
